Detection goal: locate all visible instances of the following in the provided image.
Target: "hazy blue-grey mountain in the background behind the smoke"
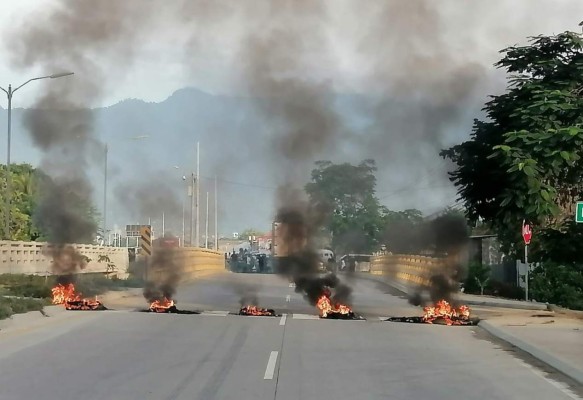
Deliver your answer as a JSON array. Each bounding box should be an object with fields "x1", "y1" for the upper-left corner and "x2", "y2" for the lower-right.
[{"x1": 0, "y1": 88, "x2": 475, "y2": 234}]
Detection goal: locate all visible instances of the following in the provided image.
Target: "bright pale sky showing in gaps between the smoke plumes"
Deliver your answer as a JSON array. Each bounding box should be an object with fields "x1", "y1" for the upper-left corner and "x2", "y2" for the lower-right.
[{"x1": 0, "y1": 0, "x2": 583, "y2": 107}]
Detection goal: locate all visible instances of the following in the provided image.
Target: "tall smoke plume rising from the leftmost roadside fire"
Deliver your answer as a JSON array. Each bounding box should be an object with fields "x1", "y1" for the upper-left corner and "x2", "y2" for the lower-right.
[{"x1": 5, "y1": 0, "x2": 159, "y2": 273}]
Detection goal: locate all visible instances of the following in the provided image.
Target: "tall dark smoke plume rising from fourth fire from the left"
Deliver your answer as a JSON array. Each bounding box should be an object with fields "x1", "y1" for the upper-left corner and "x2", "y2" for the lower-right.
[{"x1": 242, "y1": 0, "x2": 351, "y2": 304}]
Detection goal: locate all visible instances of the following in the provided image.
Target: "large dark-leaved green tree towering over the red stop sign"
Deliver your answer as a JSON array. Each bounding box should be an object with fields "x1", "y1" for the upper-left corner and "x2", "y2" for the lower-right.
[{"x1": 441, "y1": 32, "x2": 583, "y2": 261}]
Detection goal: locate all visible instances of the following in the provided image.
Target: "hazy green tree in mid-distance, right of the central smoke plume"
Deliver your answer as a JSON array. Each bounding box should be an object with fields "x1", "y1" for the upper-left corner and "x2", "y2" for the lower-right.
[{"x1": 305, "y1": 160, "x2": 387, "y2": 254}]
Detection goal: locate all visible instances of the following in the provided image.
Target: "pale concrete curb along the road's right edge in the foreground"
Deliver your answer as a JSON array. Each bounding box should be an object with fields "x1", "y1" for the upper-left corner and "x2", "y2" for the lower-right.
[{"x1": 478, "y1": 321, "x2": 583, "y2": 385}]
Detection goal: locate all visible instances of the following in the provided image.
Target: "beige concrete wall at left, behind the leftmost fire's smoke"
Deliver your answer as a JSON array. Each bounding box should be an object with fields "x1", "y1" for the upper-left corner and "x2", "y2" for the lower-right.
[{"x1": 0, "y1": 240, "x2": 129, "y2": 275}]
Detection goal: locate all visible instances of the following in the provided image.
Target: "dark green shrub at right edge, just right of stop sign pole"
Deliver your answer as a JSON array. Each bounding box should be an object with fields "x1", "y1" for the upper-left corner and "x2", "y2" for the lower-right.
[{"x1": 530, "y1": 262, "x2": 583, "y2": 310}]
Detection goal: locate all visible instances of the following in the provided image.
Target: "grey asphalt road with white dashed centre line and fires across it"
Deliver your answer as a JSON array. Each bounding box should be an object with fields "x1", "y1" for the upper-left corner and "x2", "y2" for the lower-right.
[{"x1": 0, "y1": 274, "x2": 578, "y2": 400}]
